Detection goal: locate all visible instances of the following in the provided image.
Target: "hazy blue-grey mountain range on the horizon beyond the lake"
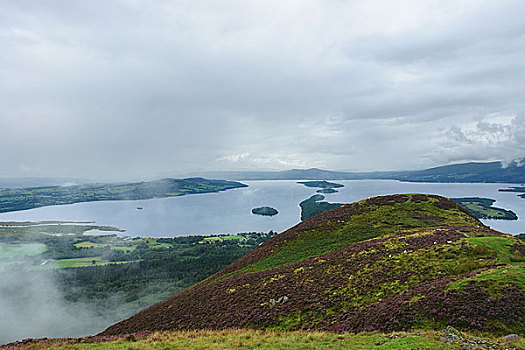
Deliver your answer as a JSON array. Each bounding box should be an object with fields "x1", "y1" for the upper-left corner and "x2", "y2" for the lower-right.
[{"x1": 202, "y1": 160, "x2": 525, "y2": 184}]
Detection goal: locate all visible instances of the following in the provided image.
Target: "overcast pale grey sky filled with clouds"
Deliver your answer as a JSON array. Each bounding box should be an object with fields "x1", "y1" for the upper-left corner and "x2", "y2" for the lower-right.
[{"x1": 0, "y1": 0, "x2": 525, "y2": 179}]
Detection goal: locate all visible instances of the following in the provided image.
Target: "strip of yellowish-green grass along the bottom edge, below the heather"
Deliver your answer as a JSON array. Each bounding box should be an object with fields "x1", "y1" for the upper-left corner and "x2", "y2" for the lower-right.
[{"x1": 9, "y1": 330, "x2": 457, "y2": 350}]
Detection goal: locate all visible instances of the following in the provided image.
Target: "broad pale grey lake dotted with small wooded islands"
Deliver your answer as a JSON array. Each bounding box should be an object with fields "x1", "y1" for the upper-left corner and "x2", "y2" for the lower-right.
[{"x1": 0, "y1": 180, "x2": 525, "y2": 237}]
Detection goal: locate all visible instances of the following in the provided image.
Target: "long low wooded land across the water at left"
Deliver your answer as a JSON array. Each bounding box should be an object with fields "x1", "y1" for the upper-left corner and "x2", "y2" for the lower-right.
[{"x1": 0, "y1": 177, "x2": 247, "y2": 213}]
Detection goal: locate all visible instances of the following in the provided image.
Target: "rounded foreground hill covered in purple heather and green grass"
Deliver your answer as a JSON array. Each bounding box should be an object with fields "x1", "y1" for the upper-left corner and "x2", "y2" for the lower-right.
[{"x1": 101, "y1": 194, "x2": 525, "y2": 336}]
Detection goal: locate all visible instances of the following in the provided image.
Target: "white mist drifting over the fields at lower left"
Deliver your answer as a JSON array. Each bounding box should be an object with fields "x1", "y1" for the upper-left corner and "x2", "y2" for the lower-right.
[{"x1": 0, "y1": 264, "x2": 136, "y2": 344}]
